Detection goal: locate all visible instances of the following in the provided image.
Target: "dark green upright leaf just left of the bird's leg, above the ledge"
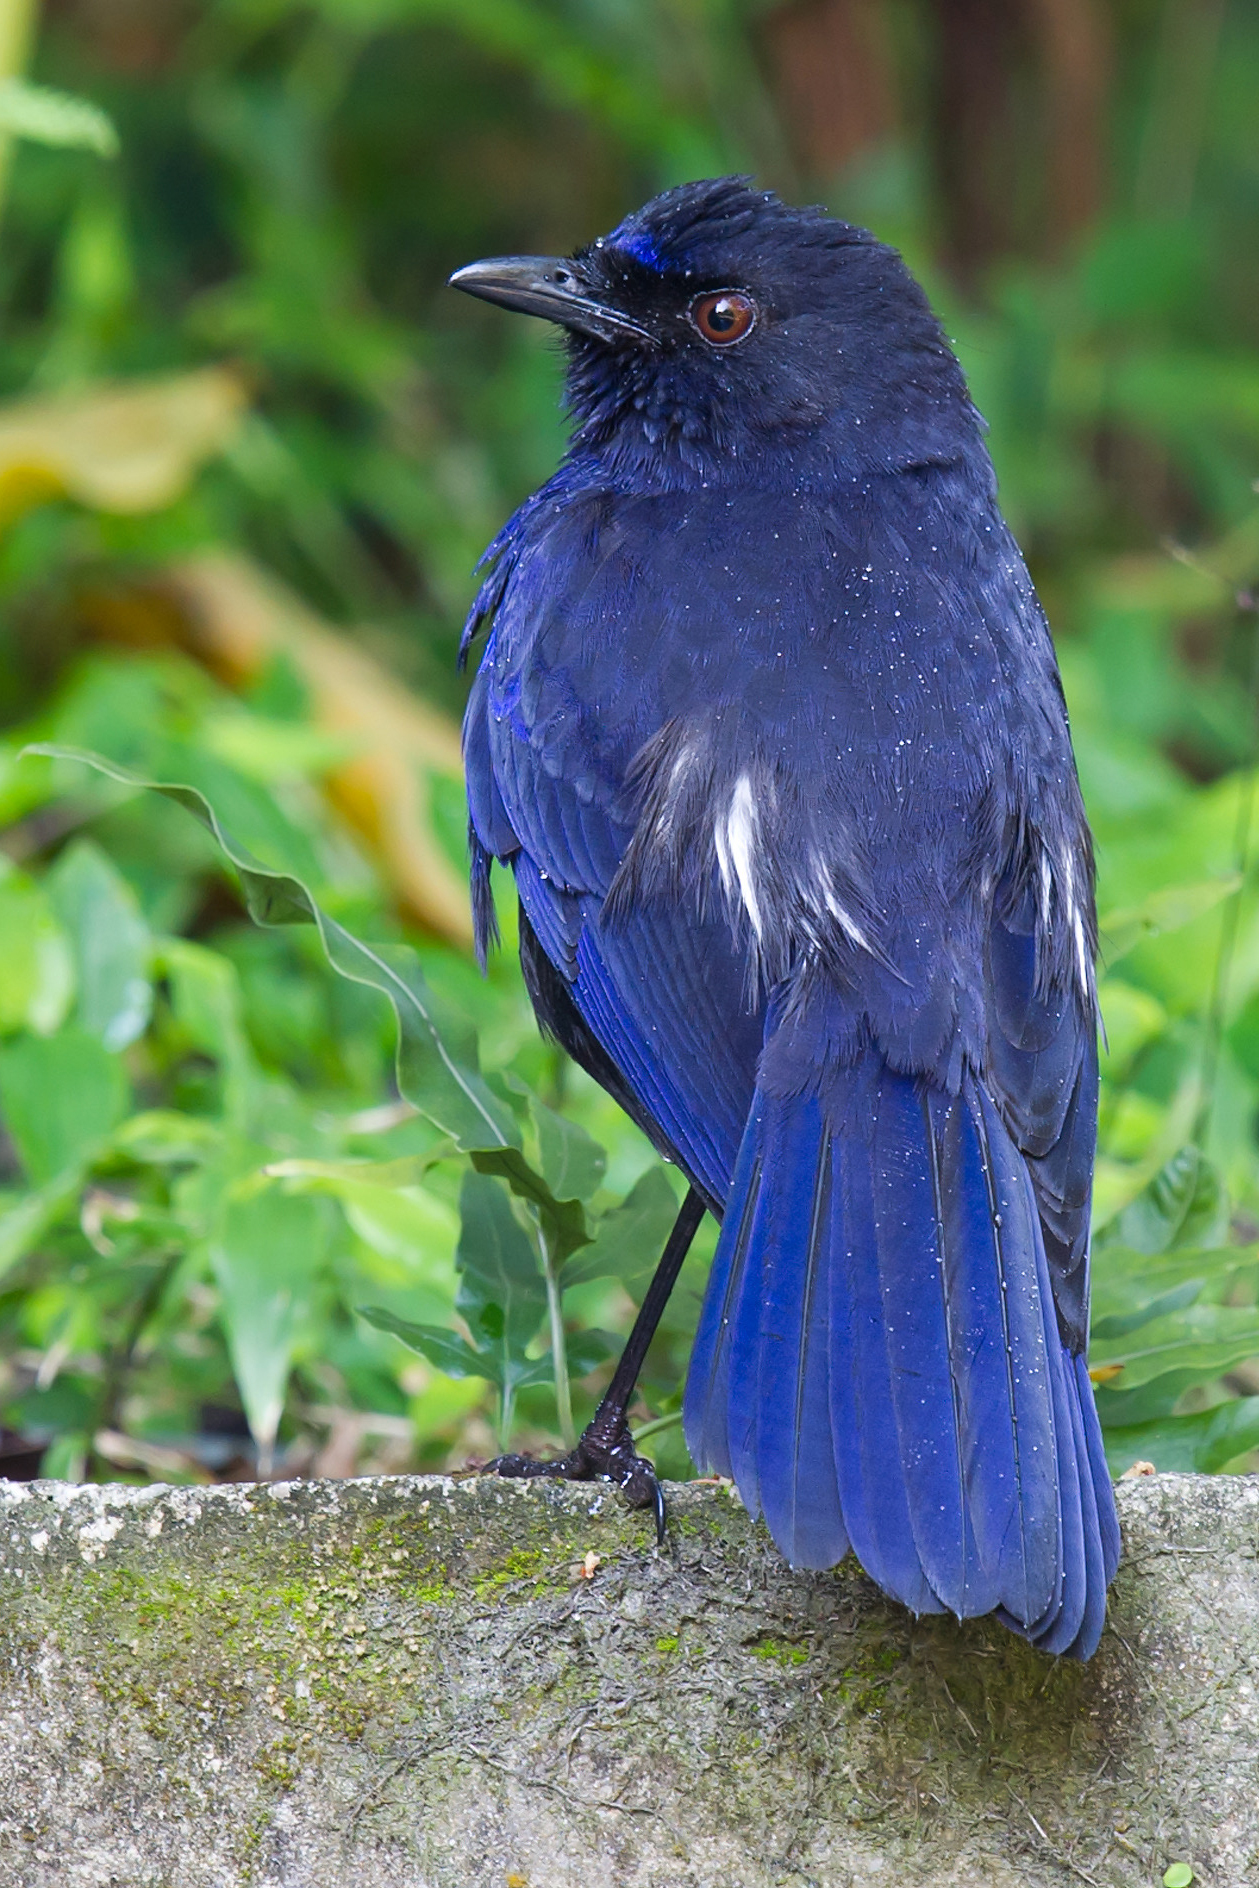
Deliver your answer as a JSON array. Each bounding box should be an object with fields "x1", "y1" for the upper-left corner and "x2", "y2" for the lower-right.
[{"x1": 455, "y1": 1171, "x2": 546, "y2": 1384}]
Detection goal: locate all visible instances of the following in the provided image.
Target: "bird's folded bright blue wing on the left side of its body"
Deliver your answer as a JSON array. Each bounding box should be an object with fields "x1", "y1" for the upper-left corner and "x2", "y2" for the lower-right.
[{"x1": 464, "y1": 602, "x2": 763, "y2": 1210}]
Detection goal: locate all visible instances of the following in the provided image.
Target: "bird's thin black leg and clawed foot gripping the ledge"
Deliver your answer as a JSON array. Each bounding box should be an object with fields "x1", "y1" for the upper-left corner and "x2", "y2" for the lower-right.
[{"x1": 487, "y1": 1188, "x2": 704, "y2": 1541}]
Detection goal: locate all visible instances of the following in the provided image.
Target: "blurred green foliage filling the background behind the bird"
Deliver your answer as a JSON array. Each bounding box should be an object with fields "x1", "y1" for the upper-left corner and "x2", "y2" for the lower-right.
[{"x1": 0, "y1": 0, "x2": 1259, "y2": 1478}]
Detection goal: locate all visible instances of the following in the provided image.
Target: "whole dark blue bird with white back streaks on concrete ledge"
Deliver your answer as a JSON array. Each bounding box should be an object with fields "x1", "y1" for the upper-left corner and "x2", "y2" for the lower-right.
[{"x1": 451, "y1": 177, "x2": 1119, "y2": 1660}]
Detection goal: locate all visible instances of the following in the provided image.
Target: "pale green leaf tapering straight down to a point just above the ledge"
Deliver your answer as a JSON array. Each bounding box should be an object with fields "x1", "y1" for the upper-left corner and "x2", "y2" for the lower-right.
[{"x1": 210, "y1": 1186, "x2": 328, "y2": 1458}]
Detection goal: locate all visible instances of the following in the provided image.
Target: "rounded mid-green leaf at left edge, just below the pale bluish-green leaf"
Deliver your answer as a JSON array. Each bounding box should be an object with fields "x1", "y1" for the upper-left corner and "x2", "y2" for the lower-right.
[{"x1": 0, "y1": 1027, "x2": 128, "y2": 1188}]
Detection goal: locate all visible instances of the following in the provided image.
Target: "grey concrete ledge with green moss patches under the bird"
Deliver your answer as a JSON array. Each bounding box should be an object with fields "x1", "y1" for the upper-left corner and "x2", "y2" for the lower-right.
[{"x1": 0, "y1": 1476, "x2": 1259, "y2": 1888}]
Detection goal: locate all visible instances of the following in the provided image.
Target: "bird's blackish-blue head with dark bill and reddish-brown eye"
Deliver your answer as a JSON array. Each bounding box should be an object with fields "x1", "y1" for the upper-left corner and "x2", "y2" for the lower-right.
[{"x1": 451, "y1": 177, "x2": 982, "y2": 483}]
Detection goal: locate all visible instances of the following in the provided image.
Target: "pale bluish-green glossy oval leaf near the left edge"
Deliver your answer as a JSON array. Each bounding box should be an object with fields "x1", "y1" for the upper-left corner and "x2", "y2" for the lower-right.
[{"x1": 47, "y1": 838, "x2": 153, "y2": 1050}]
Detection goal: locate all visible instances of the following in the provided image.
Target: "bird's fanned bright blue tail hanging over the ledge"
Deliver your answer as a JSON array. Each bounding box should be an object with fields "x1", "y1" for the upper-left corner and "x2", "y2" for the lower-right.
[{"x1": 685, "y1": 1050, "x2": 1119, "y2": 1658}]
